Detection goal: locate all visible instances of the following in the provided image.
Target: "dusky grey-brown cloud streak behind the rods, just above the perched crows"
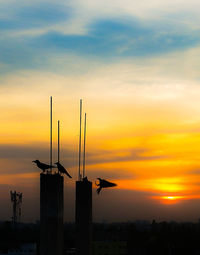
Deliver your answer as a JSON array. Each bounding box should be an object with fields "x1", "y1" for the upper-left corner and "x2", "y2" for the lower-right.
[{"x1": 0, "y1": 144, "x2": 166, "y2": 174}]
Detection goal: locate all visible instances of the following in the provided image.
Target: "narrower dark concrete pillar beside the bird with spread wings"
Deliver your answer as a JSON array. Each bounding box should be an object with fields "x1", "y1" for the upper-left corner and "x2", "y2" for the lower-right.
[{"x1": 76, "y1": 178, "x2": 92, "y2": 255}]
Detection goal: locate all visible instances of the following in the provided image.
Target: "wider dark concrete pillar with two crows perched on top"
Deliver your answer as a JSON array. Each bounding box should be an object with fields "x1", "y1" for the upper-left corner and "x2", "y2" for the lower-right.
[{"x1": 40, "y1": 173, "x2": 64, "y2": 255}]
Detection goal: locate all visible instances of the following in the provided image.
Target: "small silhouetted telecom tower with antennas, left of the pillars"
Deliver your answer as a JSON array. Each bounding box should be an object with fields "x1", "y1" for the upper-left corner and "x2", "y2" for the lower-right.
[{"x1": 10, "y1": 191, "x2": 22, "y2": 226}]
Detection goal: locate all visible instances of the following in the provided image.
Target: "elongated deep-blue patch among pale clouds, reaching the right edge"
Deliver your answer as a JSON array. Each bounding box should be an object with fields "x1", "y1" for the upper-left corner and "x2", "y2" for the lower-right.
[{"x1": 30, "y1": 21, "x2": 200, "y2": 56}]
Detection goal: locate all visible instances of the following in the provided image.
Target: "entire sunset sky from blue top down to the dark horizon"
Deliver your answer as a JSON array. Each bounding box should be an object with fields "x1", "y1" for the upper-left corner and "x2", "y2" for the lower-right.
[{"x1": 0, "y1": 0, "x2": 200, "y2": 221}]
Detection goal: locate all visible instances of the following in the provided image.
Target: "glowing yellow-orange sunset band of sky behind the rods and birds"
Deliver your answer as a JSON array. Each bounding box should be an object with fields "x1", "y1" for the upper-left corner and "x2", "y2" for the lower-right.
[{"x1": 0, "y1": 76, "x2": 200, "y2": 211}]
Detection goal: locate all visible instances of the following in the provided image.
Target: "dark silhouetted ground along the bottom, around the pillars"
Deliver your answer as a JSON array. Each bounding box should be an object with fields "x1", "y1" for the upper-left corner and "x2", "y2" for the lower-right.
[{"x1": 0, "y1": 221, "x2": 200, "y2": 255}]
